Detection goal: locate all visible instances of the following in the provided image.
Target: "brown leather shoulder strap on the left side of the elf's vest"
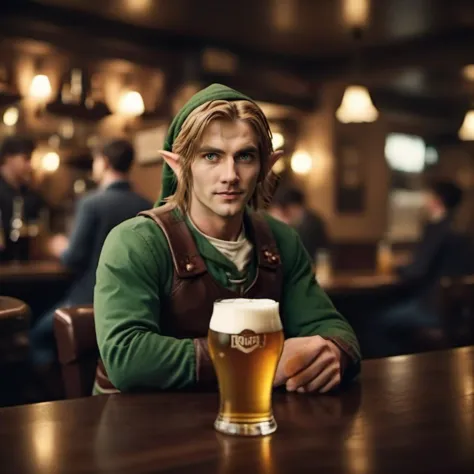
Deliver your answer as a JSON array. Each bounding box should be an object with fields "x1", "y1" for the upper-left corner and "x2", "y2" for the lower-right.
[{"x1": 138, "y1": 204, "x2": 207, "y2": 278}]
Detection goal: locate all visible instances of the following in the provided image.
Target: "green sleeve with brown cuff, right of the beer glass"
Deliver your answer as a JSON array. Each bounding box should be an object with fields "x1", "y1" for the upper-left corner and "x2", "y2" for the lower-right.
[{"x1": 281, "y1": 230, "x2": 361, "y2": 378}]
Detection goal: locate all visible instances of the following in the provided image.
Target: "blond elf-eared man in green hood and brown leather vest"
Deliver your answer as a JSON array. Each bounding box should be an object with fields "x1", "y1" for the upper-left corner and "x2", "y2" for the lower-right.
[{"x1": 94, "y1": 84, "x2": 360, "y2": 393}]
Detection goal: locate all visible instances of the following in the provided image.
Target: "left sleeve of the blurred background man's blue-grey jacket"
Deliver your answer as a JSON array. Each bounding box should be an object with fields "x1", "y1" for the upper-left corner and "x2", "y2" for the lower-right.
[{"x1": 61, "y1": 199, "x2": 97, "y2": 270}]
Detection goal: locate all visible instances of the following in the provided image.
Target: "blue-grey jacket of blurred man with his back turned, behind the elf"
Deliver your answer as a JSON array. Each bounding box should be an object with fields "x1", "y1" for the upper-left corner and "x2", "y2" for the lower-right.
[{"x1": 61, "y1": 181, "x2": 152, "y2": 305}]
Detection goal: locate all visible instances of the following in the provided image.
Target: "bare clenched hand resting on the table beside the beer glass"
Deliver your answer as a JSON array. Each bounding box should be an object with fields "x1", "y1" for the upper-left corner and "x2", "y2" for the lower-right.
[{"x1": 273, "y1": 336, "x2": 346, "y2": 393}]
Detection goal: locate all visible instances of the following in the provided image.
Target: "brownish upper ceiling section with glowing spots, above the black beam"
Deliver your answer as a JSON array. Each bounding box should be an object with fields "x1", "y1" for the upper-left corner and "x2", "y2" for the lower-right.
[{"x1": 28, "y1": 0, "x2": 474, "y2": 59}]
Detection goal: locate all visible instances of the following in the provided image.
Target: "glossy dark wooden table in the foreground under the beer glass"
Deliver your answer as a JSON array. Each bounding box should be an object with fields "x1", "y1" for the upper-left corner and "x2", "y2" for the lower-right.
[{"x1": 0, "y1": 348, "x2": 474, "y2": 474}]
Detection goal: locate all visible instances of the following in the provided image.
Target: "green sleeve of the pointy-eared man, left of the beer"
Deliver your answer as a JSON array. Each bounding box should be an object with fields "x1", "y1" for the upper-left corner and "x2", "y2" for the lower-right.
[{"x1": 94, "y1": 223, "x2": 207, "y2": 391}]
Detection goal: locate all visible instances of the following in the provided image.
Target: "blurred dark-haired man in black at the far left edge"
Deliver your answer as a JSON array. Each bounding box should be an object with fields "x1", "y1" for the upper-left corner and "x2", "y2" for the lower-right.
[{"x1": 0, "y1": 135, "x2": 44, "y2": 261}]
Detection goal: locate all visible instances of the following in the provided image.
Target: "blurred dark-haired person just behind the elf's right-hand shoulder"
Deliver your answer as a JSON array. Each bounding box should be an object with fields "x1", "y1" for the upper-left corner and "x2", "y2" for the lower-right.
[{"x1": 270, "y1": 187, "x2": 329, "y2": 260}]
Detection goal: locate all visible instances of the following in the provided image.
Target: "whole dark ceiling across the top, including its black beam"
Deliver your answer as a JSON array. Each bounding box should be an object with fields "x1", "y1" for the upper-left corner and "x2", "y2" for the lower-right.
[{"x1": 0, "y1": 0, "x2": 474, "y2": 144}]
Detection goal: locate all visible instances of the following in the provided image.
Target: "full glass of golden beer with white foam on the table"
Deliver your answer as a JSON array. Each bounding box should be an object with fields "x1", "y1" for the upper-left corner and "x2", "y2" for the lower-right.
[{"x1": 208, "y1": 298, "x2": 284, "y2": 436}]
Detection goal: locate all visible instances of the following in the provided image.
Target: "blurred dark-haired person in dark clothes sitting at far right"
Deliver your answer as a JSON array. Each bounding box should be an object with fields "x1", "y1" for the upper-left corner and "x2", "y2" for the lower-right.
[{"x1": 372, "y1": 180, "x2": 473, "y2": 355}]
